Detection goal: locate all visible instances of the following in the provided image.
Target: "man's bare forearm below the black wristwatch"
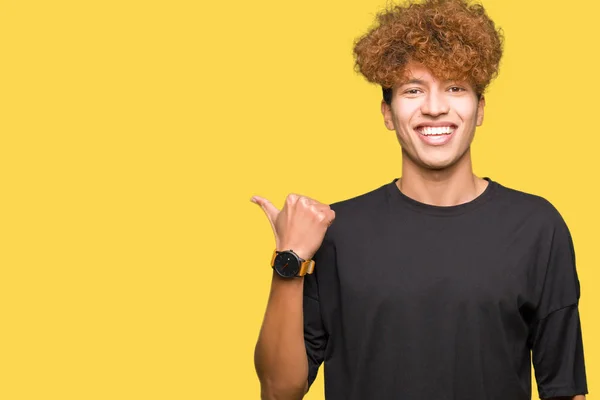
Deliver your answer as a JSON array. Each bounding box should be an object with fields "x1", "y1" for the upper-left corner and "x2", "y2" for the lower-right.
[{"x1": 254, "y1": 273, "x2": 308, "y2": 400}]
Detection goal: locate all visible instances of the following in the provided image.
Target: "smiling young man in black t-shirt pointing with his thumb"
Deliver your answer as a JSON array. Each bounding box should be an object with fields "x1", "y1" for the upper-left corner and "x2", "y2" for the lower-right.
[{"x1": 253, "y1": 0, "x2": 587, "y2": 400}]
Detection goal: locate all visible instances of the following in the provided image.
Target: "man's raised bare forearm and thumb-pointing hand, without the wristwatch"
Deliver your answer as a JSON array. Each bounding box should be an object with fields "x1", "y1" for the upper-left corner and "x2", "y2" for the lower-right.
[{"x1": 253, "y1": 195, "x2": 335, "y2": 400}]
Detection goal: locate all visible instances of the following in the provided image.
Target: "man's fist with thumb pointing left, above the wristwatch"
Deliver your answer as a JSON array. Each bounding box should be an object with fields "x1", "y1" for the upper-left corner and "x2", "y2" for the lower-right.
[{"x1": 251, "y1": 194, "x2": 335, "y2": 260}]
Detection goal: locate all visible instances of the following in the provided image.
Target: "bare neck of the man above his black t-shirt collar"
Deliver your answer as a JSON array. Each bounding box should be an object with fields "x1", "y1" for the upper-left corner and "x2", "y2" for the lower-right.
[{"x1": 396, "y1": 149, "x2": 488, "y2": 207}]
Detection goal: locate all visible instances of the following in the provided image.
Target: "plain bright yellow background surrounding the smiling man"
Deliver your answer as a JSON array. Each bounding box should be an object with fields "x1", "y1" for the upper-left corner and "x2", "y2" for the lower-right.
[{"x1": 0, "y1": 0, "x2": 600, "y2": 400}]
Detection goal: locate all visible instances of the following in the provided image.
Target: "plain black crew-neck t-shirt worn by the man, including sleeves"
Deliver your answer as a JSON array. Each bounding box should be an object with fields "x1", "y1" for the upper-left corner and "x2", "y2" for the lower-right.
[{"x1": 304, "y1": 178, "x2": 587, "y2": 400}]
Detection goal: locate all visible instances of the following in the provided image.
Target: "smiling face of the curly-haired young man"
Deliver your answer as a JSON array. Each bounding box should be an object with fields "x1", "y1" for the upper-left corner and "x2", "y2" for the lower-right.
[{"x1": 381, "y1": 64, "x2": 485, "y2": 170}]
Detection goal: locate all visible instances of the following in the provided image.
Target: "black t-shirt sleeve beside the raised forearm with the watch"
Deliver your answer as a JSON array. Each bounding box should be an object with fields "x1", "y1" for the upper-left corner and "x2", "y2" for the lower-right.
[{"x1": 304, "y1": 237, "x2": 335, "y2": 387}]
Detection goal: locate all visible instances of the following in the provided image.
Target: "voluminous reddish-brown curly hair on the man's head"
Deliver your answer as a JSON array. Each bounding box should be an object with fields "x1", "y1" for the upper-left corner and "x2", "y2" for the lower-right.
[{"x1": 354, "y1": 0, "x2": 504, "y2": 103}]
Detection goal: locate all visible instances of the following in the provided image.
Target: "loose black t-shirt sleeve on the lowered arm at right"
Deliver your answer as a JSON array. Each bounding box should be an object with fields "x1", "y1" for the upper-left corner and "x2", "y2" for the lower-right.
[{"x1": 530, "y1": 211, "x2": 587, "y2": 399}]
